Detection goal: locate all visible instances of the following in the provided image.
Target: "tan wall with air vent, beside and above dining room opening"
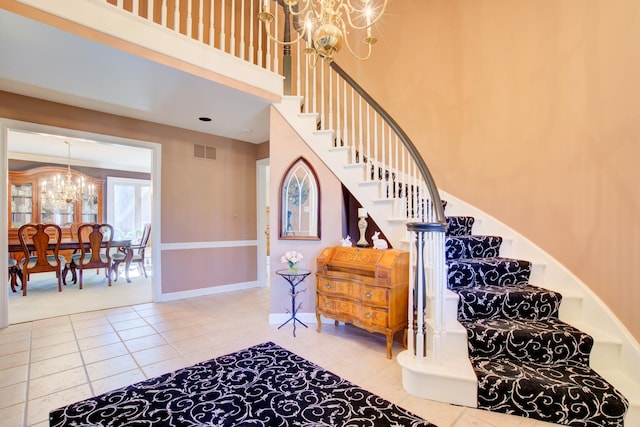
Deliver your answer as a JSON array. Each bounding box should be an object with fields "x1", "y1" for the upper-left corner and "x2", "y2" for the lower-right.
[{"x1": 0, "y1": 92, "x2": 257, "y2": 292}]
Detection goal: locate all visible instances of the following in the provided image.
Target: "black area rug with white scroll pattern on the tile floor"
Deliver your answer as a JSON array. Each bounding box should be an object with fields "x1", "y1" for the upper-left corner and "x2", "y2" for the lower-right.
[{"x1": 49, "y1": 342, "x2": 434, "y2": 427}]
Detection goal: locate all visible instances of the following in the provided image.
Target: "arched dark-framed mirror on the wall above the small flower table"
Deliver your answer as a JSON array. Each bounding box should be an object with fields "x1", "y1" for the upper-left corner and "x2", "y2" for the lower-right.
[{"x1": 280, "y1": 157, "x2": 320, "y2": 240}]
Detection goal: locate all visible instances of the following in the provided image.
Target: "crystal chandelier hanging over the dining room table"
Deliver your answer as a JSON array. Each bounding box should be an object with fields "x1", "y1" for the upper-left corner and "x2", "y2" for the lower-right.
[{"x1": 41, "y1": 141, "x2": 94, "y2": 211}]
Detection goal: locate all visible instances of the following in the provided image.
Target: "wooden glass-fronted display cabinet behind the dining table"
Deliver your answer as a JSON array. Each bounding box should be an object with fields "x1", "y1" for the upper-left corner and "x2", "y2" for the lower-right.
[{"x1": 8, "y1": 166, "x2": 104, "y2": 239}]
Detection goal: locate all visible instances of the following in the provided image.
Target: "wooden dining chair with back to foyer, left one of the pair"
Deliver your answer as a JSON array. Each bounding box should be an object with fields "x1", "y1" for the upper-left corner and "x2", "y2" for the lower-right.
[{"x1": 18, "y1": 224, "x2": 67, "y2": 296}]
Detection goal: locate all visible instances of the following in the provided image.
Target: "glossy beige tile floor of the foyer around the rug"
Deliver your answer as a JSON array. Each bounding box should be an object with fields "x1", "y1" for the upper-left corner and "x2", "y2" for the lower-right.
[{"x1": 0, "y1": 288, "x2": 560, "y2": 427}]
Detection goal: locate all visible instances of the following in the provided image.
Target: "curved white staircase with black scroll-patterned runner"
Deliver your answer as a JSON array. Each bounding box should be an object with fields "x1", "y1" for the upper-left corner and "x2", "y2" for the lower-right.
[{"x1": 275, "y1": 97, "x2": 640, "y2": 426}]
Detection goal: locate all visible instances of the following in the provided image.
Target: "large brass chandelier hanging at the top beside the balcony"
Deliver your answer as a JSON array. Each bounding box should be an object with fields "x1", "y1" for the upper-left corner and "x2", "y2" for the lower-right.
[{"x1": 258, "y1": 0, "x2": 387, "y2": 62}]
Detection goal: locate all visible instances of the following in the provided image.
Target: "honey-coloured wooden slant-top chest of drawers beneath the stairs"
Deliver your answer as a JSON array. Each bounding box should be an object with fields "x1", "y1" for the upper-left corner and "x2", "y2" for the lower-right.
[{"x1": 316, "y1": 246, "x2": 409, "y2": 359}]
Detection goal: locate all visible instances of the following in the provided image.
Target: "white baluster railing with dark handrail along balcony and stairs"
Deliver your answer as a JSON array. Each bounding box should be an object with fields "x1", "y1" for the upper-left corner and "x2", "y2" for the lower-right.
[{"x1": 102, "y1": 0, "x2": 446, "y2": 361}]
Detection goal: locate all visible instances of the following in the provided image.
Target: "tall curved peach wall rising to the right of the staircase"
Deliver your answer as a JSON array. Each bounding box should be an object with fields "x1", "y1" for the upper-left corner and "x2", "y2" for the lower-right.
[{"x1": 337, "y1": 0, "x2": 640, "y2": 339}]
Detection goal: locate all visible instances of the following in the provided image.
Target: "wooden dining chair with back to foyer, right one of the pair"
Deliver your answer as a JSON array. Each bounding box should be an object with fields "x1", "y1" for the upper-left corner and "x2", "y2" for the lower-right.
[{"x1": 71, "y1": 223, "x2": 113, "y2": 289}]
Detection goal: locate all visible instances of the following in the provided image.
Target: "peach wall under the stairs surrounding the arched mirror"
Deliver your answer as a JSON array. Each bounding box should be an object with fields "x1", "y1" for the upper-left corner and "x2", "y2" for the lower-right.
[{"x1": 269, "y1": 107, "x2": 342, "y2": 313}]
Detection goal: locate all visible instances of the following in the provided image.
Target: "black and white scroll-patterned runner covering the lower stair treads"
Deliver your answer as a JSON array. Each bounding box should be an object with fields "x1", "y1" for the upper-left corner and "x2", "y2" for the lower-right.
[{"x1": 446, "y1": 212, "x2": 629, "y2": 427}]
